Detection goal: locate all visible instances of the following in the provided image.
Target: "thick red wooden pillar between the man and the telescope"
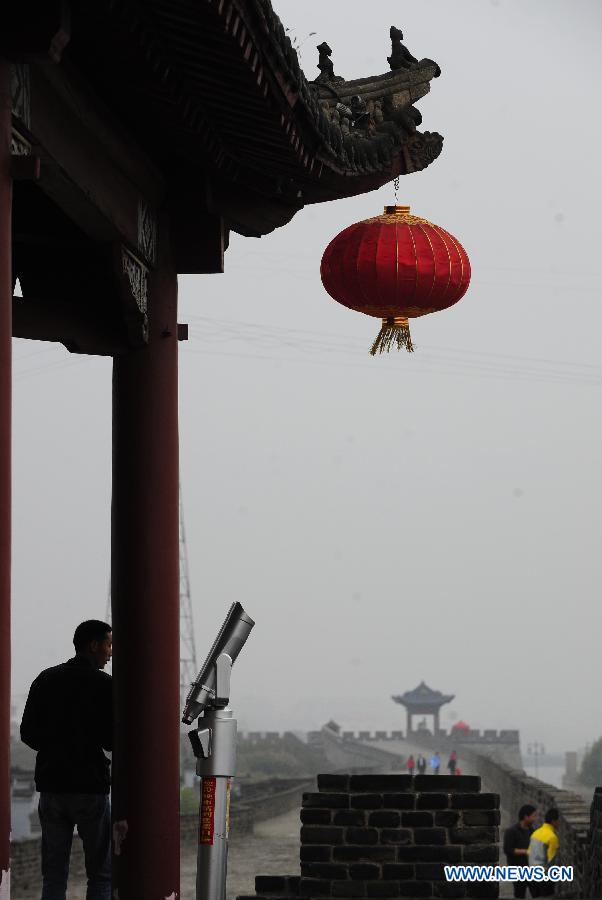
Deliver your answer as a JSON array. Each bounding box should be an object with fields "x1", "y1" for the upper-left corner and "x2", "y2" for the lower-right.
[{"x1": 111, "y1": 230, "x2": 181, "y2": 900}]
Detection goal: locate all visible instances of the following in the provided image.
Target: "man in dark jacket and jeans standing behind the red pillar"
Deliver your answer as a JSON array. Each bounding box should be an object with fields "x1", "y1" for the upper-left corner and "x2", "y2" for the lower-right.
[{"x1": 21, "y1": 619, "x2": 113, "y2": 900}]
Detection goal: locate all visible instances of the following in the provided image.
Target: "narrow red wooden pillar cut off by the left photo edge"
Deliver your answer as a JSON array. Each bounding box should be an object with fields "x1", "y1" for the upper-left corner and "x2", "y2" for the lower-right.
[{"x1": 0, "y1": 59, "x2": 12, "y2": 900}]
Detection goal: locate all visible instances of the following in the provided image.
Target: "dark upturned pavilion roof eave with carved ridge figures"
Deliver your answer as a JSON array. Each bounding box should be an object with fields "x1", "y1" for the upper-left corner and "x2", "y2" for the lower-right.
[{"x1": 63, "y1": 0, "x2": 443, "y2": 235}]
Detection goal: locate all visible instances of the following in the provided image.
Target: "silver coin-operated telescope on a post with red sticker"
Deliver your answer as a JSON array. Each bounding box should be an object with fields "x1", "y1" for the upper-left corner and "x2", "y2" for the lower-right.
[{"x1": 182, "y1": 603, "x2": 255, "y2": 900}]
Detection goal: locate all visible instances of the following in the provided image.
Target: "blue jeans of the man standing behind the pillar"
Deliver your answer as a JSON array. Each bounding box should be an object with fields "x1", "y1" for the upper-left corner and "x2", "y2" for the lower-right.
[{"x1": 38, "y1": 792, "x2": 111, "y2": 900}]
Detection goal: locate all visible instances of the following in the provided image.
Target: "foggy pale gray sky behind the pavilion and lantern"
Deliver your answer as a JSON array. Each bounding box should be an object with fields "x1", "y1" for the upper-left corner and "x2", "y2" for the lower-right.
[{"x1": 13, "y1": 0, "x2": 602, "y2": 750}]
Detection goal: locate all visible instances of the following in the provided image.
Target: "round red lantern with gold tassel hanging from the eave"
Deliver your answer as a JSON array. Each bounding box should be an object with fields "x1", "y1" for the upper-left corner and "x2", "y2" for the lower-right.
[{"x1": 320, "y1": 206, "x2": 470, "y2": 356}]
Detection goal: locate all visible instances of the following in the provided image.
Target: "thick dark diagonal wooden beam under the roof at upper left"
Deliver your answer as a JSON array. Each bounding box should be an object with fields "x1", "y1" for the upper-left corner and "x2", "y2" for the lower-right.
[{"x1": 13, "y1": 64, "x2": 165, "y2": 266}]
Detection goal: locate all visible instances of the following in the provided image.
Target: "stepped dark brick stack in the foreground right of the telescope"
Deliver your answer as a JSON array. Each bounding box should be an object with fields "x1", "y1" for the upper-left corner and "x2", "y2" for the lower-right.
[{"x1": 238, "y1": 775, "x2": 500, "y2": 900}]
